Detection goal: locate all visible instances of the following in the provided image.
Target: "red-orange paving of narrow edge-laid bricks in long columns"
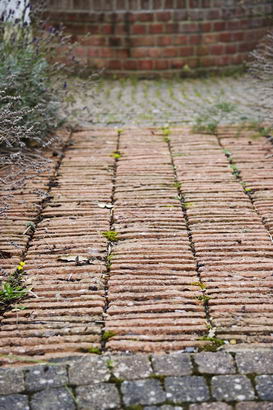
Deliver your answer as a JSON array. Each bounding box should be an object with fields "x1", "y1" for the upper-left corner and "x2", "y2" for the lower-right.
[{"x1": 0, "y1": 128, "x2": 273, "y2": 357}]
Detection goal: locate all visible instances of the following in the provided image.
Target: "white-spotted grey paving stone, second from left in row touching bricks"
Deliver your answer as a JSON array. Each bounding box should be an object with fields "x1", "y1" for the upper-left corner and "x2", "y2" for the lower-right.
[{"x1": 25, "y1": 366, "x2": 68, "y2": 391}]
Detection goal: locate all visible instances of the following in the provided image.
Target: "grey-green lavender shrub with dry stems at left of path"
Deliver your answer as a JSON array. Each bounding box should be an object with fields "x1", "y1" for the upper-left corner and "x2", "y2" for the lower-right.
[{"x1": 0, "y1": 0, "x2": 93, "y2": 212}]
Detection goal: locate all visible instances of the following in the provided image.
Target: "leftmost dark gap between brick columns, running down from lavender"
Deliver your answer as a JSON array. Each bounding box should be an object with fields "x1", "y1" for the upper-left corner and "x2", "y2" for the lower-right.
[{"x1": 21, "y1": 135, "x2": 73, "y2": 261}]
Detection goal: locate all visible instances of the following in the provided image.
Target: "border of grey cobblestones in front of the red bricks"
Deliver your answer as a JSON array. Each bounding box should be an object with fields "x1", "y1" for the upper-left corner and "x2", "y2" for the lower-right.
[{"x1": 0, "y1": 349, "x2": 273, "y2": 410}]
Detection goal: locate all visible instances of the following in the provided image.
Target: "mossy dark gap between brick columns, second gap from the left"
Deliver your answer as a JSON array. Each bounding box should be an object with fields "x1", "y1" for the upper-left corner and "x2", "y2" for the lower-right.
[{"x1": 101, "y1": 130, "x2": 122, "y2": 352}]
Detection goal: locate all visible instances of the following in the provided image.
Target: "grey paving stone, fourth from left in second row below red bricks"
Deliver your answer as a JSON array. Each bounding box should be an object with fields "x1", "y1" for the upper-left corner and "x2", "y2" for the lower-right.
[{"x1": 121, "y1": 379, "x2": 166, "y2": 406}]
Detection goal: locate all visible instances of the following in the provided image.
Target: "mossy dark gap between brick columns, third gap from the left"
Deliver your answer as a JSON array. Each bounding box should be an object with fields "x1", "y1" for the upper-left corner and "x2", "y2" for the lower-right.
[{"x1": 165, "y1": 131, "x2": 216, "y2": 329}]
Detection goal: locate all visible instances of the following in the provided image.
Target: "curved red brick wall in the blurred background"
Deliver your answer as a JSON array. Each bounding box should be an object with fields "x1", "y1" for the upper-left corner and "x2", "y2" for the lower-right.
[{"x1": 48, "y1": 0, "x2": 273, "y2": 74}]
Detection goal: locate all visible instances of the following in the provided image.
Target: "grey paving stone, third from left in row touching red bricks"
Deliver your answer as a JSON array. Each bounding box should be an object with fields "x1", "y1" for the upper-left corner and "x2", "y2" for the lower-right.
[{"x1": 68, "y1": 356, "x2": 111, "y2": 386}]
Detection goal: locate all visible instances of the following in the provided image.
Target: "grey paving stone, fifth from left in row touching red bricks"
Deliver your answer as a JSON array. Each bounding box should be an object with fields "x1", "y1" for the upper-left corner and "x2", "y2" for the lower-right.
[{"x1": 152, "y1": 353, "x2": 192, "y2": 376}]
